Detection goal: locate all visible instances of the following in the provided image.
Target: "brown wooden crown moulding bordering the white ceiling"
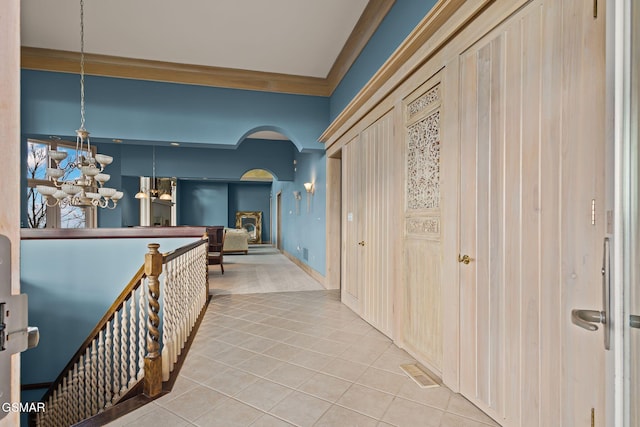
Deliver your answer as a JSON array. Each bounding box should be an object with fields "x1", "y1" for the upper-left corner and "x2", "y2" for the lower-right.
[{"x1": 21, "y1": 0, "x2": 395, "y2": 97}]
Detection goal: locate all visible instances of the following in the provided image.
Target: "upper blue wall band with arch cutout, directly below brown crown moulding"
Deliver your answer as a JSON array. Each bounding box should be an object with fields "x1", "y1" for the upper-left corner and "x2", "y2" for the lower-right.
[{"x1": 21, "y1": 70, "x2": 329, "y2": 154}]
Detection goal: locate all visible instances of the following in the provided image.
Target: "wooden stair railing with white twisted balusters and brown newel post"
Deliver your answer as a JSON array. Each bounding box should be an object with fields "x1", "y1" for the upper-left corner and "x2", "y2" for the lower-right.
[{"x1": 34, "y1": 235, "x2": 208, "y2": 427}]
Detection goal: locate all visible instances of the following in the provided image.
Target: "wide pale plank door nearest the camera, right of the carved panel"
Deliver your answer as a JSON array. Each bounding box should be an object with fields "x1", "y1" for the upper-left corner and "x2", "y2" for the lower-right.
[{"x1": 459, "y1": 0, "x2": 605, "y2": 427}]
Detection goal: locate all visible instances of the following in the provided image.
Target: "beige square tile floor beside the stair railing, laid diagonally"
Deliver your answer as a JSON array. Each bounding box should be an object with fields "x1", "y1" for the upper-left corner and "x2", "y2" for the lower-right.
[{"x1": 110, "y1": 249, "x2": 497, "y2": 427}]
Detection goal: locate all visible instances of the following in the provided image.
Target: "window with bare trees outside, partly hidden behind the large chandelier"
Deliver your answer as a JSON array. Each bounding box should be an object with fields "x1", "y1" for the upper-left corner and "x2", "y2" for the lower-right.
[{"x1": 27, "y1": 139, "x2": 96, "y2": 228}]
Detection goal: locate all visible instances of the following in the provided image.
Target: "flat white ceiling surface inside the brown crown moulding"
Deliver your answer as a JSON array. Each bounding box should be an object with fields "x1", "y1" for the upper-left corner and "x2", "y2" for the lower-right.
[{"x1": 21, "y1": 0, "x2": 368, "y2": 78}]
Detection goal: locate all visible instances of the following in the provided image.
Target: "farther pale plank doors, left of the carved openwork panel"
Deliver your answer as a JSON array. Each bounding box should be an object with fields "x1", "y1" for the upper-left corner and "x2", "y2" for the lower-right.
[{"x1": 342, "y1": 113, "x2": 398, "y2": 336}]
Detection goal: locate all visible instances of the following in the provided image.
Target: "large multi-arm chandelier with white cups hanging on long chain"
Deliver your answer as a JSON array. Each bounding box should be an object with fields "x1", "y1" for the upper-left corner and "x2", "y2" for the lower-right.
[{"x1": 36, "y1": 0, "x2": 124, "y2": 209}]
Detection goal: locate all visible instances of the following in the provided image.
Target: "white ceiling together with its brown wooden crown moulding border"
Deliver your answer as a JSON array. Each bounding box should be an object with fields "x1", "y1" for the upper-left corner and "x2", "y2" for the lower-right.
[{"x1": 21, "y1": 0, "x2": 394, "y2": 96}]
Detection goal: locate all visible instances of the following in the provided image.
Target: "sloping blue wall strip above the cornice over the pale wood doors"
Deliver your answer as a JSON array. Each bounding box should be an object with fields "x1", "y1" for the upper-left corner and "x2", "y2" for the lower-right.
[{"x1": 329, "y1": 0, "x2": 436, "y2": 121}]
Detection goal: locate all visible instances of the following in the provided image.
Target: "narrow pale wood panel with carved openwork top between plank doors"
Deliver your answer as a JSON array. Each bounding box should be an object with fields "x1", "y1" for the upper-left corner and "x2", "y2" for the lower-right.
[{"x1": 399, "y1": 77, "x2": 444, "y2": 376}]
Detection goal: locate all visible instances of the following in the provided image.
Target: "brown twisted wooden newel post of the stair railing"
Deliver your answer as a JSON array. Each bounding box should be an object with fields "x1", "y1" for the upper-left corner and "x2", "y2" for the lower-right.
[{"x1": 144, "y1": 243, "x2": 162, "y2": 397}]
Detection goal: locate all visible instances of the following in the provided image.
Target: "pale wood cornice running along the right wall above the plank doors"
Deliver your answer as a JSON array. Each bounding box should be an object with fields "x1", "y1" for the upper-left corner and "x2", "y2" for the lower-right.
[{"x1": 318, "y1": 0, "x2": 496, "y2": 148}]
